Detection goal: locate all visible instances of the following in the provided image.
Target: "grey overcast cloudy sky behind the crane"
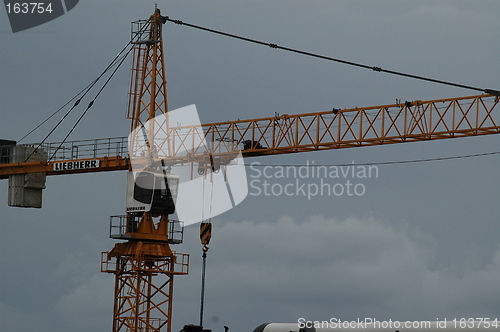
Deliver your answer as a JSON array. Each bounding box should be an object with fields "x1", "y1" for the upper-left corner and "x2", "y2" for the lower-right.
[{"x1": 0, "y1": 0, "x2": 500, "y2": 332}]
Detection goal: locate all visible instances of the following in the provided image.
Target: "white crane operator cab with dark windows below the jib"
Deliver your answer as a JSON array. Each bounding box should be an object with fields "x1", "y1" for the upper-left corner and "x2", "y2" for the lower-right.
[{"x1": 127, "y1": 171, "x2": 179, "y2": 214}]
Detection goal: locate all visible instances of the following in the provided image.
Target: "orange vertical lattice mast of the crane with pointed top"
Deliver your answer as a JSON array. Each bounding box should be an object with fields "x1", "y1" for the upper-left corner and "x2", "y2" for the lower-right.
[{"x1": 101, "y1": 9, "x2": 189, "y2": 332}]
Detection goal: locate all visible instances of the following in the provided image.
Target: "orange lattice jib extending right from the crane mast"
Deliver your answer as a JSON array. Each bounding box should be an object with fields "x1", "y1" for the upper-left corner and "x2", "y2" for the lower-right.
[{"x1": 196, "y1": 95, "x2": 500, "y2": 163}]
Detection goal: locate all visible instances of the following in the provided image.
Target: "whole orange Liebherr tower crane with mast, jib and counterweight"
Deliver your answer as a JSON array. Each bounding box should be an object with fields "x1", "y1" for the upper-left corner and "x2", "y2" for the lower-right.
[{"x1": 0, "y1": 9, "x2": 500, "y2": 332}]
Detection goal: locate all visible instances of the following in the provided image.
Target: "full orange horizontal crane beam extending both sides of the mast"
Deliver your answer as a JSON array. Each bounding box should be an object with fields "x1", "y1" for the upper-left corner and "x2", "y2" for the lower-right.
[{"x1": 0, "y1": 95, "x2": 500, "y2": 178}]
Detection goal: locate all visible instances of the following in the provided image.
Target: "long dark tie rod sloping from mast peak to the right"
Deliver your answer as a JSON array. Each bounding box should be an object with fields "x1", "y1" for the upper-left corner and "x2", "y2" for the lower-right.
[{"x1": 166, "y1": 16, "x2": 500, "y2": 96}]
